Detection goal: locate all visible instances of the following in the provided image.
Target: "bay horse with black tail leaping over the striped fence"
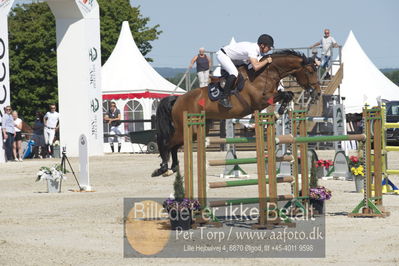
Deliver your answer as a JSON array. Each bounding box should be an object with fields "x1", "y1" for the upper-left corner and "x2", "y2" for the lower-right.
[{"x1": 152, "y1": 50, "x2": 321, "y2": 176}]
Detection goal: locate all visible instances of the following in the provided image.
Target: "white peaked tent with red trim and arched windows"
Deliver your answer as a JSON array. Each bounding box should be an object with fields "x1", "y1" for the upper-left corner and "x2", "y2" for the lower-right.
[{"x1": 101, "y1": 21, "x2": 186, "y2": 151}]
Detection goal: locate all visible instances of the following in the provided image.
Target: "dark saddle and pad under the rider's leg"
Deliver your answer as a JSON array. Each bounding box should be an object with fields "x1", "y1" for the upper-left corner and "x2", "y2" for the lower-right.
[{"x1": 208, "y1": 69, "x2": 245, "y2": 101}]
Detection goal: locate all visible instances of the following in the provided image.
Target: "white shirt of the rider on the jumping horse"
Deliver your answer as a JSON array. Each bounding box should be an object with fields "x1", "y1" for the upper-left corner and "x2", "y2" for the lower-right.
[{"x1": 223, "y1": 42, "x2": 260, "y2": 62}]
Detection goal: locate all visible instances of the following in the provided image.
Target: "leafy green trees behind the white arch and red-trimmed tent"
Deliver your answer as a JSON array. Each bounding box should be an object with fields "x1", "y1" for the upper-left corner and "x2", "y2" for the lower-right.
[{"x1": 8, "y1": 0, "x2": 162, "y2": 122}]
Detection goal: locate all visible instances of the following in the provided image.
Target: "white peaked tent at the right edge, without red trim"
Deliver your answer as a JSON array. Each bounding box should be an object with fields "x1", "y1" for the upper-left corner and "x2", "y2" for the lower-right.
[{"x1": 340, "y1": 31, "x2": 399, "y2": 113}]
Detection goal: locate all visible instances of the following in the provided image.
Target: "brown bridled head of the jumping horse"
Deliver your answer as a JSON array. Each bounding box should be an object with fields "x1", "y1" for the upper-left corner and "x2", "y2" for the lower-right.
[{"x1": 292, "y1": 57, "x2": 321, "y2": 103}]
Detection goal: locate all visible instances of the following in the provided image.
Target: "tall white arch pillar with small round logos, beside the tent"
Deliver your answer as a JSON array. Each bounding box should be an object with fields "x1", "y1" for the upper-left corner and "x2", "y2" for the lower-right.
[{"x1": 47, "y1": 0, "x2": 103, "y2": 156}]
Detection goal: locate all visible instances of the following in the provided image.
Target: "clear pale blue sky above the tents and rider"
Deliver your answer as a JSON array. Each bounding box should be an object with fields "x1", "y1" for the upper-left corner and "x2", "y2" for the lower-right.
[{"x1": 130, "y1": 0, "x2": 399, "y2": 68}]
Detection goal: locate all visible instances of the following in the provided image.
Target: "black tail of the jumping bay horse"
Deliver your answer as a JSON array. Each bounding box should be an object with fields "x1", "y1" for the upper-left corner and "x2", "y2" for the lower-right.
[{"x1": 155, "y1": 96, "x2": 177, "y2": 152}]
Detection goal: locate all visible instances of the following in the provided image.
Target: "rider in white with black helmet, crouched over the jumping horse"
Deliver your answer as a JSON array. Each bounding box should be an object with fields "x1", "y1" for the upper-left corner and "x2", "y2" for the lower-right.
[{"x1": 216, "y1": 34, "x2": 274, "y2": 108}]
